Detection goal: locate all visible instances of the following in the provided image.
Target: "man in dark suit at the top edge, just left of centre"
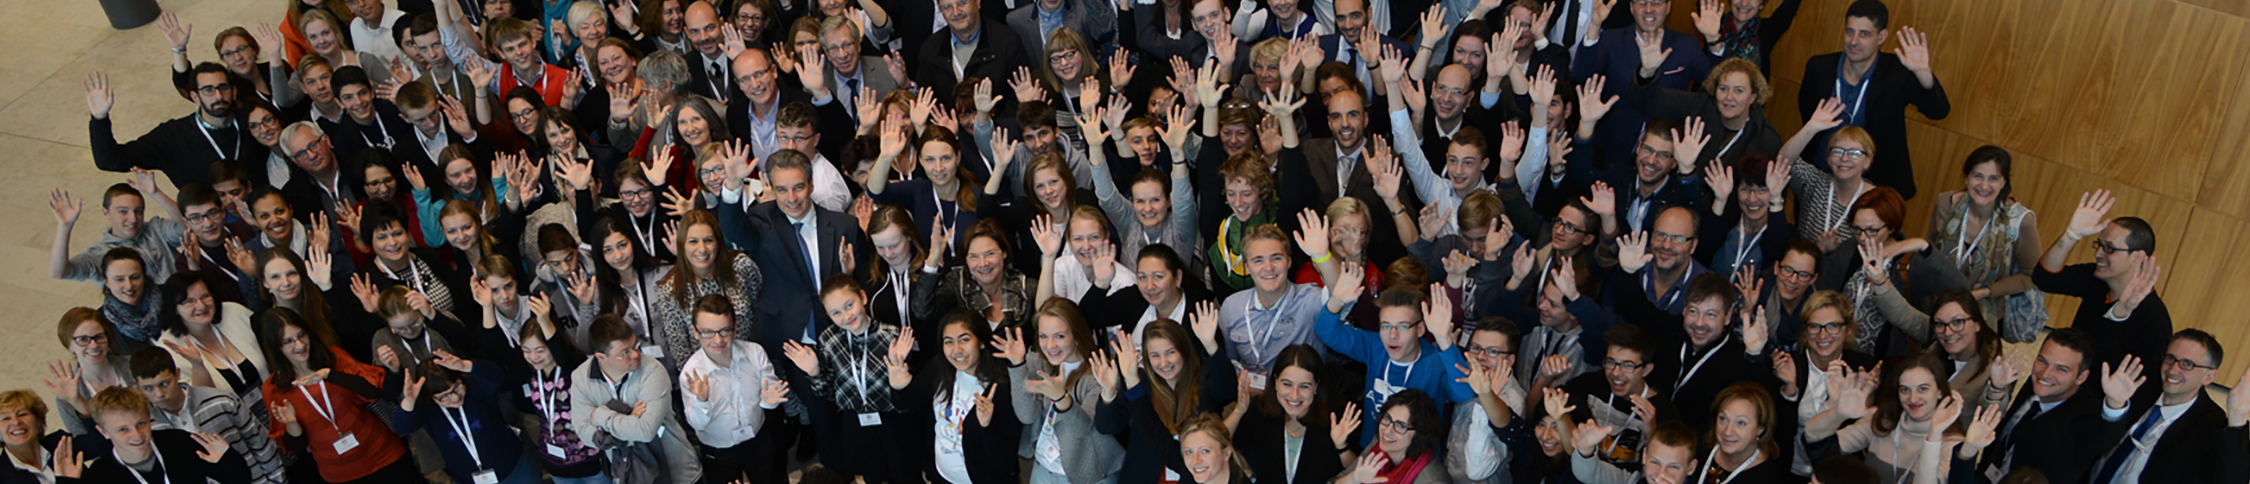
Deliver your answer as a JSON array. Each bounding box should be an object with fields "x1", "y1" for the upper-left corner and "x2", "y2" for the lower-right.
[{"x1": 914, "y1": 0, "x2": 1033, "y2": 108}]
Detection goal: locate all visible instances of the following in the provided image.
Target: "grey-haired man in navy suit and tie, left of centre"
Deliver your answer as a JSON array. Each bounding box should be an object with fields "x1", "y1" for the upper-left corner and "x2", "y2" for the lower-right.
[{"x1": 713, "y1": 151, "x2": 875, "y2": 358}]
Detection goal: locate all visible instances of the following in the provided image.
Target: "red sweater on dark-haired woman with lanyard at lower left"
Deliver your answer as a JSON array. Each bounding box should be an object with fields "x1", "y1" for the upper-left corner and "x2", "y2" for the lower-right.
[{"x1": 261, "y1": 347, "x2": 407, "y2": 482}]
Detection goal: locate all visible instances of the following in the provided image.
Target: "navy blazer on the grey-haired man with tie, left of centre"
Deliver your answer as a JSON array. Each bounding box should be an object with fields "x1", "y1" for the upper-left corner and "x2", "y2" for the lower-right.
[{"x1": 713, "y1": 200, "x2": 875, "y2": 358}]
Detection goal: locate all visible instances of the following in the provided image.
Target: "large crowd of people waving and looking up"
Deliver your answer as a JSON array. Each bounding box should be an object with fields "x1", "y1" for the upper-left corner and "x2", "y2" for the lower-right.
[{"x1": 13, "y1": 0, "x2": 2250, "y2": 484}]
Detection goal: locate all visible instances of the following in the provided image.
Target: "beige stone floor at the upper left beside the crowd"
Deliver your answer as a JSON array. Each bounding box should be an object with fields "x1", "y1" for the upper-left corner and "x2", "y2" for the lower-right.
[{"x1": 0, "y1": 0, "x2": 281, "y2": 428}]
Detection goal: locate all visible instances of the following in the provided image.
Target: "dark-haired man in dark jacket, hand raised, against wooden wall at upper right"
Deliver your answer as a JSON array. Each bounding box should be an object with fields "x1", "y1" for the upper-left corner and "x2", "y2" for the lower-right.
[{"x1": 1791, "y1": 0, "x2": 1953, "y2": 200}]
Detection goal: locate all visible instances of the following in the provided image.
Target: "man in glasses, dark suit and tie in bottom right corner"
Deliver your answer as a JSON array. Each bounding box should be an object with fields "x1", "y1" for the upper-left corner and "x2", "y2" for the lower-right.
[{"x1": 2090, "y1": 329, "x2": 2250, "y2": 484}]
